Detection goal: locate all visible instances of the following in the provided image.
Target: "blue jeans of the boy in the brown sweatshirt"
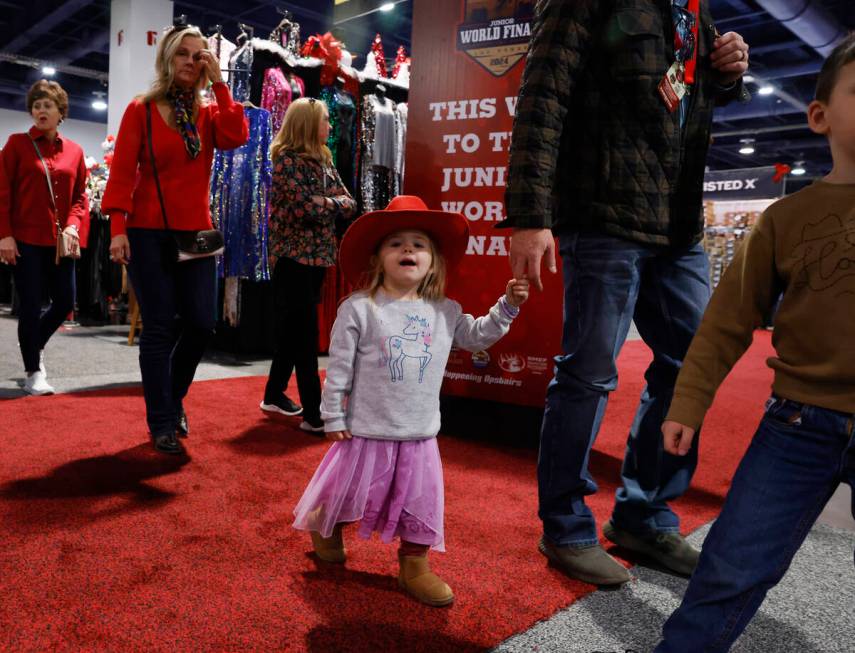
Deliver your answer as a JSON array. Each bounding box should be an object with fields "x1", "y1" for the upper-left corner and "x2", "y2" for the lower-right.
[{"x1": 656, "y1": 397, "x2": 855, "y2": 653}]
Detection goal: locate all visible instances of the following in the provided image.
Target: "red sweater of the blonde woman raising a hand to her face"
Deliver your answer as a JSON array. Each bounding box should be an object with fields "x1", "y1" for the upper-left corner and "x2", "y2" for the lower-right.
[{"x1": 101, "y1": 83, "x2": 249, "y2": 236}]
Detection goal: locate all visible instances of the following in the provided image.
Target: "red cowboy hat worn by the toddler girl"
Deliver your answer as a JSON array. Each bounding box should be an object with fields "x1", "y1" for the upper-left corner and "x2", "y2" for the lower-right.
[{"x1": 338, "y1": 195, "x2": 469, "y2": 284}]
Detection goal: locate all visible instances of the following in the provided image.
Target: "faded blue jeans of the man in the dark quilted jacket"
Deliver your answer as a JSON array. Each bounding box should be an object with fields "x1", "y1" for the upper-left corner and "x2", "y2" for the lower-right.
[{"x1": 537, "y1": 233, "x2": 710, "y2": 547}]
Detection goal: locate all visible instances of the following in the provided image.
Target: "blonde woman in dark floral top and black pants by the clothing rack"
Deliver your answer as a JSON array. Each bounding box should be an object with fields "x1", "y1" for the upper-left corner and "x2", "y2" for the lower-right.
[{"x1": 261, "y1": 98, "x2": 356, "y2": 433}]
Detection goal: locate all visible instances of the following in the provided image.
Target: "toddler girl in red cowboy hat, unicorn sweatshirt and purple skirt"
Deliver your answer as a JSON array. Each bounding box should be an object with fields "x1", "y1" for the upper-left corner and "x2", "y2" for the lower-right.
[{"x1": 294, "y1": 196, "x2": 529, "y2": 606}]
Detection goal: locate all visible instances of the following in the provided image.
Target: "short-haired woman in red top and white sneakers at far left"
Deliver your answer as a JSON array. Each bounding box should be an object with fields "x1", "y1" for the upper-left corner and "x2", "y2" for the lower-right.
[{"x1": 0, "y1": 79, "x2": 89, "y2": 395}]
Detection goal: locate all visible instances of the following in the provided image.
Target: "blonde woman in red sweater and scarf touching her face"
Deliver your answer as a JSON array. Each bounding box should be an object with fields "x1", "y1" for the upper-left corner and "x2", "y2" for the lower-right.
[{"x1": 101, "y1": 25, "x2": 249, "y2": 454}]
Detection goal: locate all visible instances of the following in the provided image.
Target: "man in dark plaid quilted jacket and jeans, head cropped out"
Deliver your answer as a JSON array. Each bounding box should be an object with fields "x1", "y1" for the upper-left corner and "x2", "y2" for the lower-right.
[{"x1": 500, "y1": 0, "x2": 748, "y2": 585}]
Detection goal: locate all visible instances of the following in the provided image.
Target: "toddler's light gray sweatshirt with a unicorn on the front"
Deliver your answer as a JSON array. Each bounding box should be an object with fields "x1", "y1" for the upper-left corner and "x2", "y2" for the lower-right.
[{"x1": 321, "y1": 290, "x2": 517, "y2": 440}]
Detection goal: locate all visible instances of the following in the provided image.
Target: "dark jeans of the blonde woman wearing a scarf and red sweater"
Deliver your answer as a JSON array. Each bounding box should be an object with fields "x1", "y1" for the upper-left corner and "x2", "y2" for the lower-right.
[{"x1": 128, "y1": 229, "x2": 217, "y2": 436}]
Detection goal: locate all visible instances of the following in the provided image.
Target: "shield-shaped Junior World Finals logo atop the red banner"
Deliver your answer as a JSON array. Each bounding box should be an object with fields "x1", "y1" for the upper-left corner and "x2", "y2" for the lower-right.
[{"x1": 457, "y1": 0, "x2": 534, "y2": 77}]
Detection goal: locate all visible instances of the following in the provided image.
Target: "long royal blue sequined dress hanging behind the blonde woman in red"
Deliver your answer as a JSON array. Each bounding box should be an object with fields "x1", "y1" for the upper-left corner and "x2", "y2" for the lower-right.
[{"x1": 211, "y1": 107, "x2": 272, "y2": 281}]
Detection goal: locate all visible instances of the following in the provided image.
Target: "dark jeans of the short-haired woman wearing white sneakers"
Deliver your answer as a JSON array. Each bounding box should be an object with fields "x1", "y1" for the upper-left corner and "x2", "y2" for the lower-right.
[{"x1": 12, "y1": 242, "x2": 75, "y2": 374}]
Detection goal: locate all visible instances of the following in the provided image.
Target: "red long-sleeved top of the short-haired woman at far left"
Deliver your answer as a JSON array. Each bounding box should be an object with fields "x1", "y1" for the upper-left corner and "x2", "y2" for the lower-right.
[{"x1": 0, "y1": 127, "x2": 89, "y2": 246}]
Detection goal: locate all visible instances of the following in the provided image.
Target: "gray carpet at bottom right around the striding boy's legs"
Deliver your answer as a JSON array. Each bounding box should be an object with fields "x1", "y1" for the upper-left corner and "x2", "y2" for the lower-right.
[{"x1": 494, "y1": 525, "x2": 855, "y2": 653}]
